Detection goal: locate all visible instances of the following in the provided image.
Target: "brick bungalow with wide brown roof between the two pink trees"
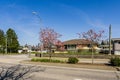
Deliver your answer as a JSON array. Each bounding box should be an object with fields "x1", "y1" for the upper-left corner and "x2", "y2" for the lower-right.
[{"x1": 63, "y1": 39, "x2": 98, "y2": 50}]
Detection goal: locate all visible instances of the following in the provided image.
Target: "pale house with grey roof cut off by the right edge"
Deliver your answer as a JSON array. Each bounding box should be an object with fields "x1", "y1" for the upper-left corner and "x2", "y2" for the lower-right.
[{"x1": 112, "y1": 38, "x2": 120, "y2": 55}]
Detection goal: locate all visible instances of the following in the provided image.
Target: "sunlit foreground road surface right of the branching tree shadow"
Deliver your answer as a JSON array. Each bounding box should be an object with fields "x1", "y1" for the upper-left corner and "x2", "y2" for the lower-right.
[{"x1": 32, "y1": 67, "x2": 120, "y2": 80}]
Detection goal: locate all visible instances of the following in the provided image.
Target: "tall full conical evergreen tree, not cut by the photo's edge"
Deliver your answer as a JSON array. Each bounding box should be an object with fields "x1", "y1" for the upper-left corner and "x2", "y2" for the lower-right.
[{"x1": 6, "y1": 28, "x2": 19, "y2": 53}]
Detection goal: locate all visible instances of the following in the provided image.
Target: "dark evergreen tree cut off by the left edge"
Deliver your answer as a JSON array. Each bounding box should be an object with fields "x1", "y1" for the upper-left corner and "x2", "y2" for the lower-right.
[{"x1": 0, "y1": 29, "x2": 5, "y2": 53}]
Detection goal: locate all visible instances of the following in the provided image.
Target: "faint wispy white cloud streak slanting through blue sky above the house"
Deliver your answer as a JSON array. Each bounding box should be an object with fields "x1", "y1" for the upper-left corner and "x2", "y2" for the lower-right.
[{"x1": 61, "y1": 4, "x2": 109, "y2": 29}]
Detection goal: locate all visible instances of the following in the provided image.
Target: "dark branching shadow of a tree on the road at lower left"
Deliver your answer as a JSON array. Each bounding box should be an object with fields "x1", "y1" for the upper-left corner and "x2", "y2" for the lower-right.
[{"x1": 0, "y1": 65, "x2": 45, "y2": 80}]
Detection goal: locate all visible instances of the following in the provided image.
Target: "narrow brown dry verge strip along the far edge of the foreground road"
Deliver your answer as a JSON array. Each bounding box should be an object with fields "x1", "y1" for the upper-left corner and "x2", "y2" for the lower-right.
[{"x1": 21, "y1": 61, "x2": 118, "y2": 71}]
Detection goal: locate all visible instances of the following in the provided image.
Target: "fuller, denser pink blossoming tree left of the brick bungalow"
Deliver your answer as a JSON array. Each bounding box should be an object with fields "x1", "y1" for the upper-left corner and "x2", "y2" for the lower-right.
[{"x1": 40, "y1": 27, "x2": 61, "y2": 58}]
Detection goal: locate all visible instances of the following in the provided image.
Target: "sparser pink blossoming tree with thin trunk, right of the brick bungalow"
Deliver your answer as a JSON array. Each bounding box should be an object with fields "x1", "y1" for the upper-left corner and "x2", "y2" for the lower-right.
[{"x1": 78, "y1": 29, "x2": 104, "y2": 64}]
